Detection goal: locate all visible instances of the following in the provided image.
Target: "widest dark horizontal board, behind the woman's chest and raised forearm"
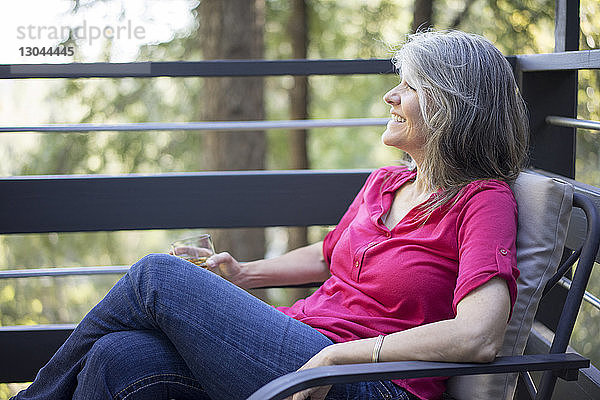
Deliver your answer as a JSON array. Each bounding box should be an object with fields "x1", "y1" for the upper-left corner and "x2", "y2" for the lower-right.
[{"x1": 0, "y1": 170, "x2": 368, "y2": 233}]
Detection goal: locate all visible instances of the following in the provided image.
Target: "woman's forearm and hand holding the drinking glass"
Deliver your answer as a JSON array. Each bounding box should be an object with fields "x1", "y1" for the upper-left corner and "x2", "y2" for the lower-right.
[{"x1": 207, "y1": 242, "x2": 329, "y2": 289}]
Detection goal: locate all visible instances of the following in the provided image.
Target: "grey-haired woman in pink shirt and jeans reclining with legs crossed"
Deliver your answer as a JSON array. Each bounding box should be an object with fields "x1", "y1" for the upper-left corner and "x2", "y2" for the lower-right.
[{"x1": 16, "y1": 31, "x2": 527, "y2": 400}]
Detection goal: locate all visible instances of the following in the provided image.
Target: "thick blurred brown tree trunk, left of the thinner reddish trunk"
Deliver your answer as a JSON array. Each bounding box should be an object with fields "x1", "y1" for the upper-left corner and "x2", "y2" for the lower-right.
[{"x1": 197, "y1": 0, "x2": 266, "y2": 297}]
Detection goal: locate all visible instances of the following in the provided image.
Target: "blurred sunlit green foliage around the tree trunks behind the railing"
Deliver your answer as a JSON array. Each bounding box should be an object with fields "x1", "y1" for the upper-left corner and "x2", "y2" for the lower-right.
[{"x1": 0, "y1": 0, "x2": 600, "y2": 398}]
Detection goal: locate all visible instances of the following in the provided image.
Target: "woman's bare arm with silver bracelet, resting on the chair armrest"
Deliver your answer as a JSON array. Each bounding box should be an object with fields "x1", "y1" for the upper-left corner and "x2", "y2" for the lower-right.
[{"x1": 293, "y1": 278, "x2": 510, "y2": 400}]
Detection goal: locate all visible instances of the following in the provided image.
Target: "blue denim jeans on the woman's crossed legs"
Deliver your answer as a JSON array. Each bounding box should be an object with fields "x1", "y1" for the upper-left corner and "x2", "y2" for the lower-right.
[{"x1": 15, "y1": 254, "x2": 414, "y2": 400}]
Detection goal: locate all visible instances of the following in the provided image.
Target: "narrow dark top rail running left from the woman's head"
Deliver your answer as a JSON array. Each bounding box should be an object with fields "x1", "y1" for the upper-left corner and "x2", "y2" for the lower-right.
[{"x1": 0, "y1": 59, "x2": 395, "y2": 79}]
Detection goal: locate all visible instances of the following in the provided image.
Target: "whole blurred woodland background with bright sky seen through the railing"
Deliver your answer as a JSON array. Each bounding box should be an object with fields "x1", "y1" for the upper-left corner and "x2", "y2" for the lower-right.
[{"x1": 0, "y1": 0, "x2": 600, "y2": 399}]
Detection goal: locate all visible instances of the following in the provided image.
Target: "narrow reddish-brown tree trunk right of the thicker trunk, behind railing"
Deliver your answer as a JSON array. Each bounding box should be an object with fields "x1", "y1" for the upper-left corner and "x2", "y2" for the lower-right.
[{"x1": 288, "y1": 0, "x2": 309, "y2": 302}]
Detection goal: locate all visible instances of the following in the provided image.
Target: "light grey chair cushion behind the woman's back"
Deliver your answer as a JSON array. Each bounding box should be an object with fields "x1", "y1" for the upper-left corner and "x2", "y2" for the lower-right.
[{"x1": 447, "y1": 172, "x2": 573, "y2": 400}]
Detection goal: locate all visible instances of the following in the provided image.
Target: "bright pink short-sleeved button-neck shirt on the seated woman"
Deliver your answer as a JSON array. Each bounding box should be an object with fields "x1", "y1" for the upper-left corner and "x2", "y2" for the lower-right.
[{"x1": 279, "y1": 167, "x2": 519, "y2": 399}]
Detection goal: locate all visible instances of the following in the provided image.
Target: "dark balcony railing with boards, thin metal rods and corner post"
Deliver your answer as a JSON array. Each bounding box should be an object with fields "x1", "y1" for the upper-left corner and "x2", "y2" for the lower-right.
[{"x1": 0, "y1": 0, "x2": 600, "y2": 398}]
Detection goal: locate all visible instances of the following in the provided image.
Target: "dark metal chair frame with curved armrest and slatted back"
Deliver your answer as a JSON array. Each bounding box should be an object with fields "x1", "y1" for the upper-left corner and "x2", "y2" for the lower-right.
[{"x1": 248, "y1": 193, "x2": 600, "y2": 400}]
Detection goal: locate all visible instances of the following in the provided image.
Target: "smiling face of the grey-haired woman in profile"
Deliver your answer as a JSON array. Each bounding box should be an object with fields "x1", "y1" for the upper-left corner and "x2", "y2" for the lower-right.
[{"x1": 381, "y1": 79, "x2": 426, "y2": 164}]
